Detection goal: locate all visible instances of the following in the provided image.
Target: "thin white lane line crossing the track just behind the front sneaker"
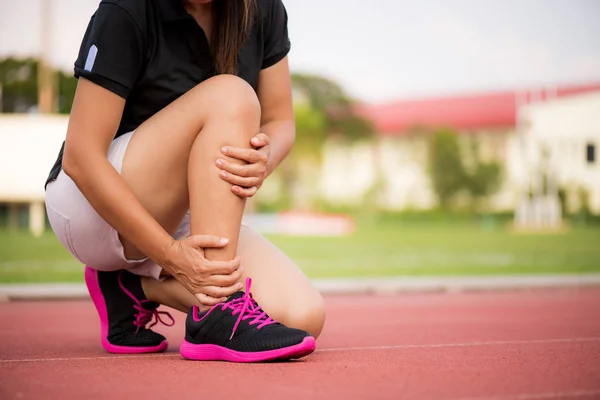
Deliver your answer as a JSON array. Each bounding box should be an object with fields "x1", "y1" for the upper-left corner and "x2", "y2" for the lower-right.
[{"x1": 0, "y1": 337, "x2": 600, "y2": 364}]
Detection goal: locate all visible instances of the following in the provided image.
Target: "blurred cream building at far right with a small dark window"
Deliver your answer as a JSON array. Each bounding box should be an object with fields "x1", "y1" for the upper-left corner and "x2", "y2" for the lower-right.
[{"x1": 515, "y1": 91, "x2": 600, "y2": 214}]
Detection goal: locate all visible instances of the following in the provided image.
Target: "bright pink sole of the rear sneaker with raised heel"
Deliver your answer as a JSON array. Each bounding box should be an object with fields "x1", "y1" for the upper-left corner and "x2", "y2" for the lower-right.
[{"x1": 85, "y1": 266, "x2": 169, "y2": 354}]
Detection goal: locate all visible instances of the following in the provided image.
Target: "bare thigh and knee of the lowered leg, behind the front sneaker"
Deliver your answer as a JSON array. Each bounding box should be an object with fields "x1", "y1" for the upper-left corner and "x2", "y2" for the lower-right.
[{"x1": 238, "y1": 226, "x2": 325, "y2": 337}]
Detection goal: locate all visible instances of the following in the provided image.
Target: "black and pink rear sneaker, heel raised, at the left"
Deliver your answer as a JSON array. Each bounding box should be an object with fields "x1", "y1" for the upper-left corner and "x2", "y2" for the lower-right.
[{"x1": 85, "y1": 266, "x2": 175, "y2": 354}]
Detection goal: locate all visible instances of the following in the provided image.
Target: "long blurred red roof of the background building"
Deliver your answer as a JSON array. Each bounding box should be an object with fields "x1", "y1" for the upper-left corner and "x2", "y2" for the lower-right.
[{"x1": 358, "y1": 83, "x2": 600, "y2": 136}]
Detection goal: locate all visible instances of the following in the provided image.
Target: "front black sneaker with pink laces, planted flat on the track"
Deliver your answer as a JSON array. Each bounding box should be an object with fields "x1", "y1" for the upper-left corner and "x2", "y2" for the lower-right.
[{"x1": 180, "y1": 278, "x2": 315, "y2": 362}]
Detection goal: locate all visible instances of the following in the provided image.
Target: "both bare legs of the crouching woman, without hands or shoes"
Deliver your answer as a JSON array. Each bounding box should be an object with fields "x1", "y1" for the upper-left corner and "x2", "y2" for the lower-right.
[{"x1": 121, "y1": 76, "x2": 324, "y2": 336}]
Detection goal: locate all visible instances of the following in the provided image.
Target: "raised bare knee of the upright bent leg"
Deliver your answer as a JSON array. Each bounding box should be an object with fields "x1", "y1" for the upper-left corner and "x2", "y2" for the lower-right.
[{"x1": 199, "y1": 75, "x2": 261, "y2": 124}]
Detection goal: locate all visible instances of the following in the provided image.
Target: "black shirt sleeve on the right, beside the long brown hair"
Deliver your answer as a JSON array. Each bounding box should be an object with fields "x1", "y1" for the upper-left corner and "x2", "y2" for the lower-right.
[{"x1": 261, "y1": 0, "x2": 291, "y2": 69}]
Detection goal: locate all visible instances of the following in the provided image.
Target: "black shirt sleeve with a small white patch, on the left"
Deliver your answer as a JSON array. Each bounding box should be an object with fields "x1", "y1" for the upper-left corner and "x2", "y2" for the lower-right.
[{"x1": 75, "y1": 2, "x2": 144, "y2": 99}]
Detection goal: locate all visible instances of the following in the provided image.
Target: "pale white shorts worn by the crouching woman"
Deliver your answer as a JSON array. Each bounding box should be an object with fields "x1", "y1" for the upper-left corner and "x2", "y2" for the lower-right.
[{"x1": 46, "y1": 132, "x2": 190, "y2": 279}]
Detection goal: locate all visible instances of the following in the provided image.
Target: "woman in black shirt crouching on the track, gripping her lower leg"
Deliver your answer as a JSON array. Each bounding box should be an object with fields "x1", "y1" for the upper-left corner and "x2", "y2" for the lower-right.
[{"x1": 46, "y1": 0, "x2": 325, "y2": 361}]
